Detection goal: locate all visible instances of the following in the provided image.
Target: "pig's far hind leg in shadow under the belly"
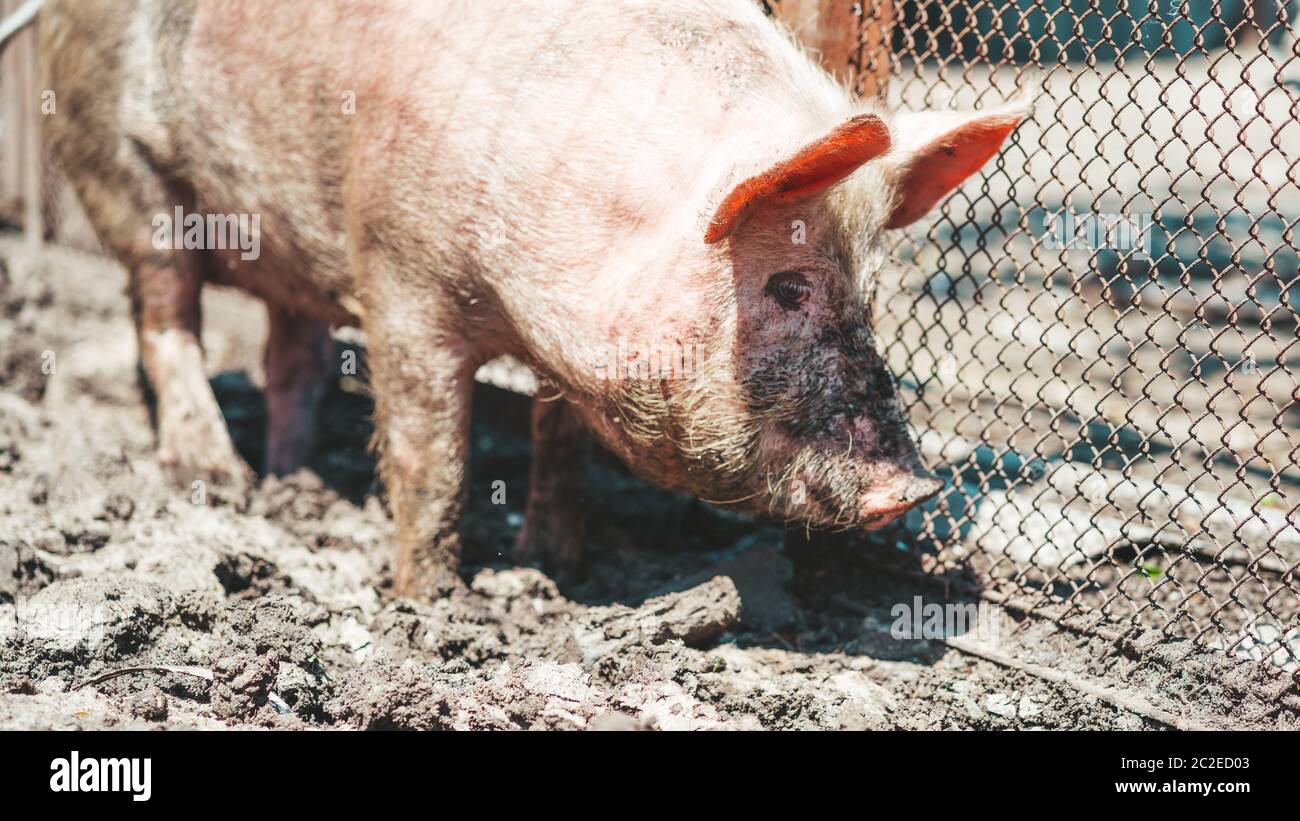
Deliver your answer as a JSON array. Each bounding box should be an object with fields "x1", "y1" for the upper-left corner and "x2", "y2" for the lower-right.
[{"x1": 265, "y1": 304, "x2": 334, "y2": 475}]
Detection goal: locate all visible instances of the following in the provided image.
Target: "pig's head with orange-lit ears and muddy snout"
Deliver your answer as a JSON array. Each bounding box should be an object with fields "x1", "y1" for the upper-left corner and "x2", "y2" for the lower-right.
[{"x1": 587, "y1": 101, "x2": 1024, "y2": 529}]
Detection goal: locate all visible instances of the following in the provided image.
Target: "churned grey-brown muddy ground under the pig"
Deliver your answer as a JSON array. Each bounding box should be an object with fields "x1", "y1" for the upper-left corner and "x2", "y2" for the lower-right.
[{"x1": 0, "y1": 236, "x2": 1300, "y2": 729}]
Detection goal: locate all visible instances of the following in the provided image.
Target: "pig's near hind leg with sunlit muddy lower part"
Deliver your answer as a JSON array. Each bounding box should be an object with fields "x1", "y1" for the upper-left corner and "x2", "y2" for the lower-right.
[{"x1": 40, "y1": 3, "x2": 248, "y2": 483}]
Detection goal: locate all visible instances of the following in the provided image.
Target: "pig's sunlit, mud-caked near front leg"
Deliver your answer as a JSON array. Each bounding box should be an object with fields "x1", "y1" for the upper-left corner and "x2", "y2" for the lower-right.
[{"x1": 365, "y1": 278, "x2": 477, "y2": 599}]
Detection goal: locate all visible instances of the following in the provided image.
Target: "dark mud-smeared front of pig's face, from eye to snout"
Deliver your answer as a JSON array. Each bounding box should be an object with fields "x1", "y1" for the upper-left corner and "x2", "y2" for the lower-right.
[{"x1": 733, "y1": 205, "x2": 917, "y2": 526}]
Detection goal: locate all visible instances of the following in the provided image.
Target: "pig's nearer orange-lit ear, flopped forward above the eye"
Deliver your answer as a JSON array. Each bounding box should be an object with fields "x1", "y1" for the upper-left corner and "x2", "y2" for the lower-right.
[{"x1": 705, "y1": 114, "x2": 889, "y2": 243}]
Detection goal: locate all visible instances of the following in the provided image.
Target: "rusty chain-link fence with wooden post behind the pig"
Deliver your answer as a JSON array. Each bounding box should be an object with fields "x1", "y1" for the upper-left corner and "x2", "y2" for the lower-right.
[{"x1": 0, "y1": 0, "x2": 1300, "y2": 676}]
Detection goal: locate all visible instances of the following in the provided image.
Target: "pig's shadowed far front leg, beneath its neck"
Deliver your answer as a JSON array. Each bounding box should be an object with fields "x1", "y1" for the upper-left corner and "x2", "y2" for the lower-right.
[{"x1": 515, "y1": 398, "x2": 590, "y2": 579}]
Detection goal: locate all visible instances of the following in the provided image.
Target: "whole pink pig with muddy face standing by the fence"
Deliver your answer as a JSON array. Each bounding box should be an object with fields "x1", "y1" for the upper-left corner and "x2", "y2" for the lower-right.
[{"x1": 30, "y1": 0, "x2": 1026, "y2": 598}]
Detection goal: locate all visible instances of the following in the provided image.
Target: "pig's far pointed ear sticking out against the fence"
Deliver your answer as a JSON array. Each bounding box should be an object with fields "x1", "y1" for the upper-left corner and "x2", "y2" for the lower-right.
[{"x1": 885, "y1": 103, "x2": 1028, "y2": 229}]
